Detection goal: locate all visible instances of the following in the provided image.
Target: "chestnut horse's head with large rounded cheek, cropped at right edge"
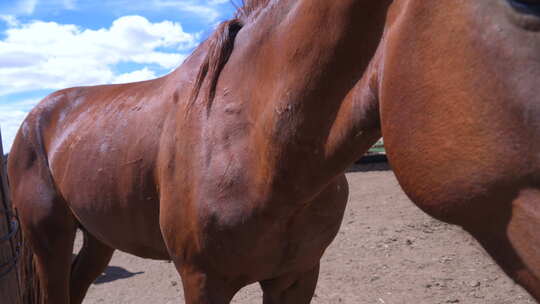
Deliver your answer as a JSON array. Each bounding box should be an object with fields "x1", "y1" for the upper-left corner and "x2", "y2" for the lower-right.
[{"x1": 377, "y1": 0, "x2": 540, "y2": 300}]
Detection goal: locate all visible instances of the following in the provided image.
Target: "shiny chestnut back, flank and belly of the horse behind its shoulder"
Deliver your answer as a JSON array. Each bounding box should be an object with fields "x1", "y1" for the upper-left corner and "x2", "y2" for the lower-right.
[{"x1": 12, "y1": 78, "x2": 177, "y2": 258}]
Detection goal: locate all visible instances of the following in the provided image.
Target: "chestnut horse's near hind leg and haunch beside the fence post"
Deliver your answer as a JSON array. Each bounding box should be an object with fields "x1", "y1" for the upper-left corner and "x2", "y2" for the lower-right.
[{"x1": 8, "y1": 129, "x2": 77, "y2": 304}]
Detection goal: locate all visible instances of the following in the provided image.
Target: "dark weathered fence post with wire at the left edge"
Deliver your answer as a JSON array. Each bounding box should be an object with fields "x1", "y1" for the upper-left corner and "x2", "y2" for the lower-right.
[{"x1": 0, "y1": 130, "x2": 21, "y2": 304}]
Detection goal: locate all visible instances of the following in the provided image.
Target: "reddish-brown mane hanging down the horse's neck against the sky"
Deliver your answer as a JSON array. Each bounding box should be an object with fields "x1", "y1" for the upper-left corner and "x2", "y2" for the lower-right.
[{"x1": 187, "y1": 0, "x2": 272, "y2": 112}]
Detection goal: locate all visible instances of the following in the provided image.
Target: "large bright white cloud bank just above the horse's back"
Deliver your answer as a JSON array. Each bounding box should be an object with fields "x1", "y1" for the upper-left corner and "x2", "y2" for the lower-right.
[{"x1": 0, "y1": 16, "x2": 198, "y2": 96}]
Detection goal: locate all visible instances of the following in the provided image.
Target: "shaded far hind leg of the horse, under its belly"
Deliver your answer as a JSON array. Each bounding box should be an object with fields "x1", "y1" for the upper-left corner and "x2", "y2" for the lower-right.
[{"x1": 70, "y1": 231, "x2": 114, "y2": 304}]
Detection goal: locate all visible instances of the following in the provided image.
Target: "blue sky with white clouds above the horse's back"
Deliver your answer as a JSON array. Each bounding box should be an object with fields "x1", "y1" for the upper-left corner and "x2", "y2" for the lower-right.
[{"x1": 0, "y1": 0, "x2": 236, "y2": 151}]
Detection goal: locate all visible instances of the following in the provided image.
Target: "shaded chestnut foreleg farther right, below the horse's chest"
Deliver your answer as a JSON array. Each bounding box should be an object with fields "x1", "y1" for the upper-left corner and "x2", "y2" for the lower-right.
[{"x1": 260, "y1": 264, "x2": 319, "y2": 304}]
